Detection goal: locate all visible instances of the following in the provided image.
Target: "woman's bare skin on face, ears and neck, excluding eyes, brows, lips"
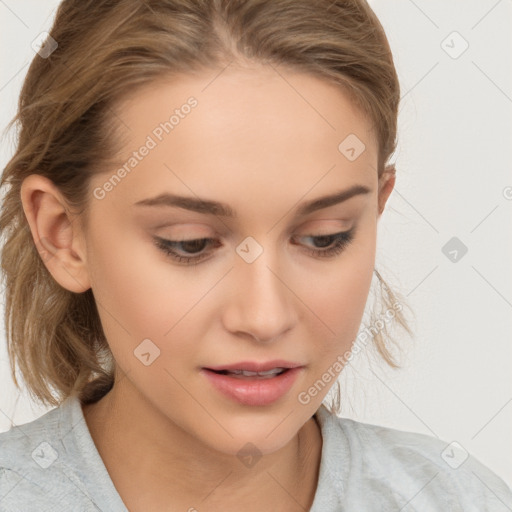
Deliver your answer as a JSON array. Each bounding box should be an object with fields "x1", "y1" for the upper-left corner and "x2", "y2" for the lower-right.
[{"x1": 21, "y1": 65, "x2": 395, "y2": 511}]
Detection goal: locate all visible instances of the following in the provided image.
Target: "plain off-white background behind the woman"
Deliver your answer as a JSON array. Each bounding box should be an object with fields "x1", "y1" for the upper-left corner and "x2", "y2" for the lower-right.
[{"x1": 0, "y1": 0, "x2": 512, "y2": 486}]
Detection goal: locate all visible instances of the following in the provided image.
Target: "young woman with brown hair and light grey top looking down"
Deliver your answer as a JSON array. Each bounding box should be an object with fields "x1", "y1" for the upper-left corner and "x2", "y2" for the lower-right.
[{"x1": 0, "y1": 0, "x2": 512, "y2": 512}]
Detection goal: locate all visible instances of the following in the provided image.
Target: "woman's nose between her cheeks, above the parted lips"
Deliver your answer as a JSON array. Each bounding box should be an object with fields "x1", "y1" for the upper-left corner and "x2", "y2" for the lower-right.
[{"x1": 223, "y1": 251, "x2": 297, "y2": 343}]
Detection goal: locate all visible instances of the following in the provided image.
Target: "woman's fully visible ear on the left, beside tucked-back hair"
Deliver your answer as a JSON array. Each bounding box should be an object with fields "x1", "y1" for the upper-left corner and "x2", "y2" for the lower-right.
[{"x1": 21, "y1": 174, "x2": 91, "y2": 293}]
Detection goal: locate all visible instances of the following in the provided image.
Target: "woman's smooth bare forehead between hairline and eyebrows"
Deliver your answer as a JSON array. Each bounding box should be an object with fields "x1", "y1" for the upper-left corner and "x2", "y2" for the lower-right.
[{"x1": 99, "y1": 65, "x2": 377, "y2": 206}]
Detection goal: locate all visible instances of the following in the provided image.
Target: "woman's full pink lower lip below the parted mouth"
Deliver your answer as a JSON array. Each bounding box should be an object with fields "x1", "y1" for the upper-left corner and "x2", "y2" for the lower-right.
[{"x1": 201, "y1": 367, "x2": 303, "y2": 405}]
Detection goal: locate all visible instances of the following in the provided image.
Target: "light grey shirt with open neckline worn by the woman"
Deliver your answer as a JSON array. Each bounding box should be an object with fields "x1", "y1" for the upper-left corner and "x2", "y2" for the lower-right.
[{"x1": 0, "y1": 397, "x2": 512, "y2": 512}]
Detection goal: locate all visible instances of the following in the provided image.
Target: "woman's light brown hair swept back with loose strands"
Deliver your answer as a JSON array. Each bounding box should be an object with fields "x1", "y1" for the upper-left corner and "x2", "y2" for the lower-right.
[{"x1": 0, "y1": 0, "x2": 411, "y2": 412}]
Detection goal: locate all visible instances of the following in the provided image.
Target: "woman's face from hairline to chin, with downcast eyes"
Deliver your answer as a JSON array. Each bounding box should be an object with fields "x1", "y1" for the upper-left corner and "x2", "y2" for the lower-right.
[{"x1": 45, "y1": 63, "x2": 390, "y2": 454}]
